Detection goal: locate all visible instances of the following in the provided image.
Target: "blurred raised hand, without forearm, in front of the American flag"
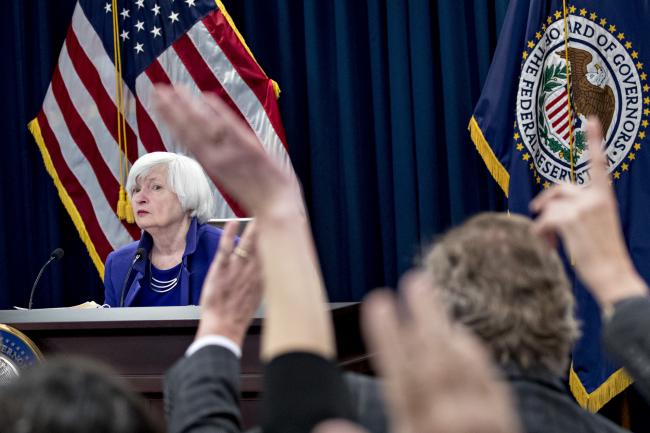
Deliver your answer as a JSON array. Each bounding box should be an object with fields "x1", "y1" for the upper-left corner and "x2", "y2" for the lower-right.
[{"x1": 156, "y1": 86, "x2": 294, "y2": 215}]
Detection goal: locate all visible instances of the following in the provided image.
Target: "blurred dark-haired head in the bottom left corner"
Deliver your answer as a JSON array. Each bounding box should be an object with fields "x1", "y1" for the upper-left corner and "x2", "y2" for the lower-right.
[{"x1": 0, "y1": 358, "x2": 161, "y2": 433}]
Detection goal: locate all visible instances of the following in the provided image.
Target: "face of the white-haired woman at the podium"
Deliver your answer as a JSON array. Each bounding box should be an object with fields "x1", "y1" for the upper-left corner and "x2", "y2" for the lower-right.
[{"x1": 130, "y1": 165, "x2": 186, "y2": 233}]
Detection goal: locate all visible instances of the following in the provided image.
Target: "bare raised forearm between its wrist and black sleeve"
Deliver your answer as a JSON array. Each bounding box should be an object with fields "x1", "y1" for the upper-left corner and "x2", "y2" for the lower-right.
[{"x1": 257, "y1": 201, "x2": 335, "y2": 360}]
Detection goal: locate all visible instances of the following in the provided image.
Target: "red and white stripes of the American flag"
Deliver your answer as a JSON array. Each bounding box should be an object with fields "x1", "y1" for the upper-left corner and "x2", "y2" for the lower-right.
[{"x1": 30, "y1": 4, "x2": 295, "y2": 273}]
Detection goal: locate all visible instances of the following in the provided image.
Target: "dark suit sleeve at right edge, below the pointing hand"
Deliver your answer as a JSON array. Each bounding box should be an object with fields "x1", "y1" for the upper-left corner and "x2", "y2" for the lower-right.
[{"x1": 603, "y1": 297, "x2": 650, "y2": 402}]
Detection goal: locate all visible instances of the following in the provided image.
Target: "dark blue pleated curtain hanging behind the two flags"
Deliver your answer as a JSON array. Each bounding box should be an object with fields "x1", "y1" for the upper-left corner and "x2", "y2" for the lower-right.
[{"x1": 0, "y1": 0, "x2": 507, "y2": 308}]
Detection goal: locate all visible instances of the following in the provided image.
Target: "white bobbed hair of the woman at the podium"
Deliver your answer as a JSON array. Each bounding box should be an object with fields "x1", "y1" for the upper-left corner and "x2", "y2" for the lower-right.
[{"x1": 126, "y1": 152, "x2": 215, "y2": 223}]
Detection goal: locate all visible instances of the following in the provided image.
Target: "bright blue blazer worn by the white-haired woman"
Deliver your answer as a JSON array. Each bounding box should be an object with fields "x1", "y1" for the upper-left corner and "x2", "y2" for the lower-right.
[{"x1": 104, "y1": 218, "x2": 221, "y2": 307}]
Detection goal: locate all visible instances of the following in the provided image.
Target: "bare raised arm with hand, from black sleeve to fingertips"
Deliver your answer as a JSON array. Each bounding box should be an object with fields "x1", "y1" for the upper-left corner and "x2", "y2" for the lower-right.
[{"x1": 156, "y1": 86, "x2": 335, "y2": 360}]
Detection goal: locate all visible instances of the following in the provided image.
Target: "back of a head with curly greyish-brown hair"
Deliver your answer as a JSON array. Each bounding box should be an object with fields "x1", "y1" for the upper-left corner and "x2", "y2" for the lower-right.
[{"x1": 423, "y1": 213, "x2": 578, "y2": 373}]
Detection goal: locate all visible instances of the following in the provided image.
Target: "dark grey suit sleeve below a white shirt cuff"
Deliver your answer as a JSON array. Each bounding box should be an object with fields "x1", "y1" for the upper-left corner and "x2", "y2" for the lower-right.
[{"x1": 165, "y1": 346, "x2": 241, "y2": 433}]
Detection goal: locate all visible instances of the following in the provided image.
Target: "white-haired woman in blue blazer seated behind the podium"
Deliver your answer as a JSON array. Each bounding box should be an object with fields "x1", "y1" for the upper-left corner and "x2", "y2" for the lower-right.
[{"x1": 104, "y1": 152, "x2": 221, "y2": 307}]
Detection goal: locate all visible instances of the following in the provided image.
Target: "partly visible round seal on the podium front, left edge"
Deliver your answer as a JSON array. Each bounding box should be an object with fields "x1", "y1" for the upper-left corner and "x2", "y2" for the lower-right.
[{"x1": 0, "y1": 325, "x2": 43, "y2": 385}]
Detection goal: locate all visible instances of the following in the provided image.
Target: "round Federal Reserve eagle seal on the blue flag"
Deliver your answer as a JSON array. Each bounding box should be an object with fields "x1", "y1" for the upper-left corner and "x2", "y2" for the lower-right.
[{"x1": 513, "y1": 6, "x2": 650, "y2": 188}]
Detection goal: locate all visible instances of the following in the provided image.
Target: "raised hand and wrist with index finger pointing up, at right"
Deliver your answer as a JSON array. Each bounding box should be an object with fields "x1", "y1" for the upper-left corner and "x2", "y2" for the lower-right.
[{"x1": 530, "y1": 117, "x2": 647, "y2": 305}]
